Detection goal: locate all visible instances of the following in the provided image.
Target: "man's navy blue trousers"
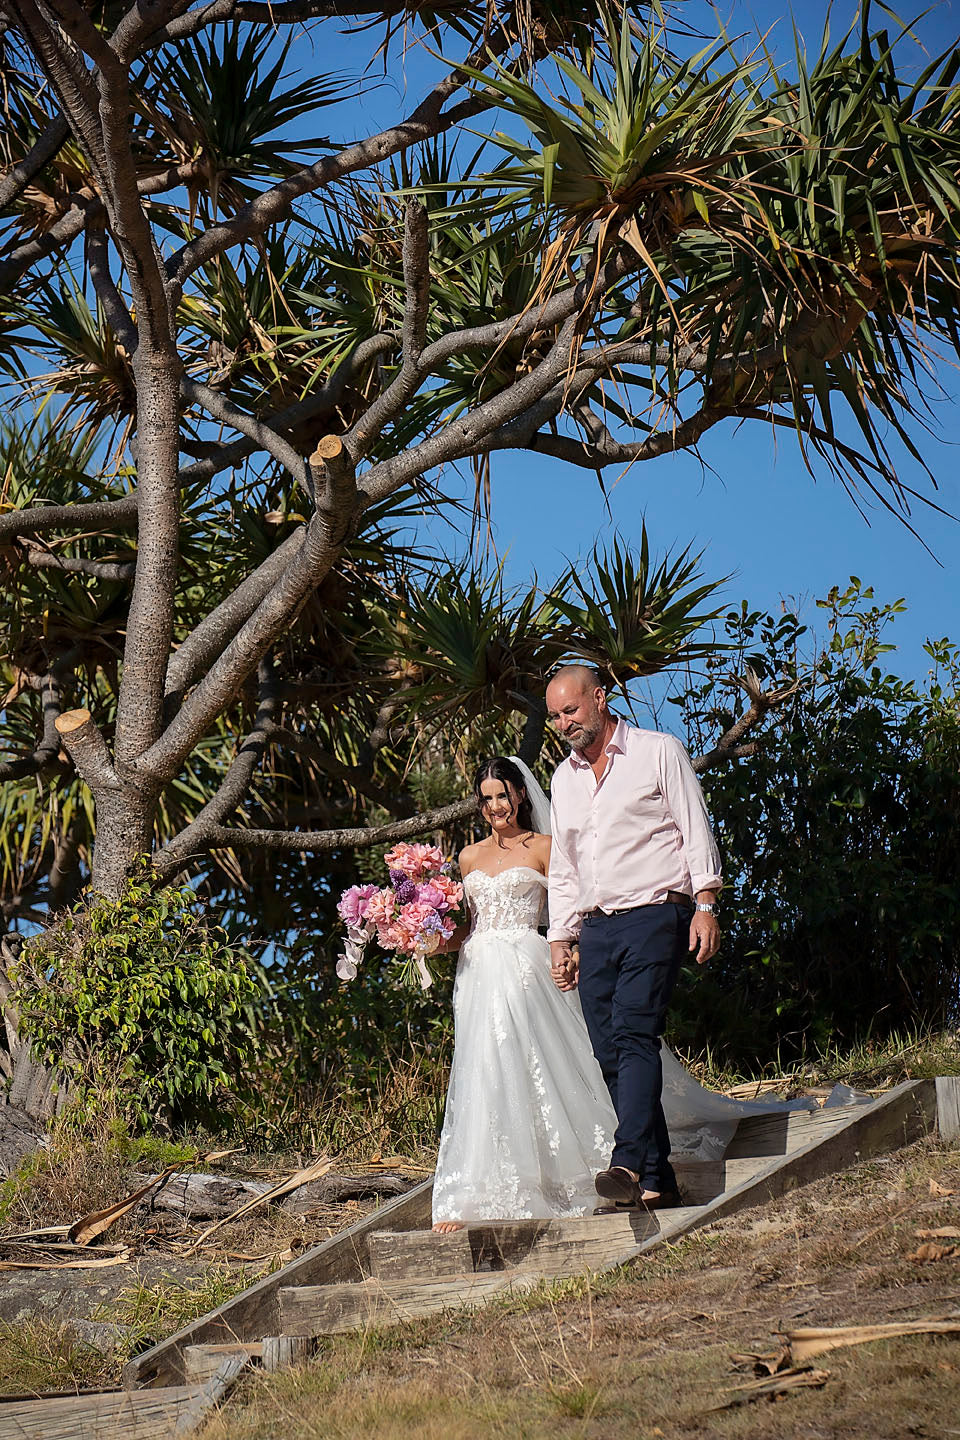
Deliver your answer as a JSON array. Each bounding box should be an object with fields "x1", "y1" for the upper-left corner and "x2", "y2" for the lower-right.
[{"x1": 580, "y1": 901, "x2": 691, "y2": 1192}]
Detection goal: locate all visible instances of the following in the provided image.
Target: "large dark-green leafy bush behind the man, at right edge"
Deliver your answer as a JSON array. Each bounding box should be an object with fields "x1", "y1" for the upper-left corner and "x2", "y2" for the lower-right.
[{"x1": 671, "y1": 579, "x2": 960, "y2": 1068}]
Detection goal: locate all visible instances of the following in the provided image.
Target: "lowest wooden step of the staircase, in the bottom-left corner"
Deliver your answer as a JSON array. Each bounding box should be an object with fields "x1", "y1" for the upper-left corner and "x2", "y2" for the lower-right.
[{"x1": 0, "y1": 1356, "x2": 246, "y2": 1440}]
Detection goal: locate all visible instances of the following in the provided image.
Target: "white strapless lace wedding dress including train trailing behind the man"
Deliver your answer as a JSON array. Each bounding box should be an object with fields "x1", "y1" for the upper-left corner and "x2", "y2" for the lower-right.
[{"x1": 433, "y1": 865, "x2": 816, "y2": 1224}]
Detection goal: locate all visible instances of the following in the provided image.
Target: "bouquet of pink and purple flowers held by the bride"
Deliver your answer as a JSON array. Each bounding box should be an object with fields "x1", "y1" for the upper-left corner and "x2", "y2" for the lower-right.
[{"x1": 337, "y1": 844, "x2": 463, "y2": 989}]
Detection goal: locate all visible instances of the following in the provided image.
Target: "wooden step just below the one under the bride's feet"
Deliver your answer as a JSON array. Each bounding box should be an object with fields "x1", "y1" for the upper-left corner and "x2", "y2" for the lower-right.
[{"x1": 281, "y1": 1270, "x2": 540, "y2": 1336}]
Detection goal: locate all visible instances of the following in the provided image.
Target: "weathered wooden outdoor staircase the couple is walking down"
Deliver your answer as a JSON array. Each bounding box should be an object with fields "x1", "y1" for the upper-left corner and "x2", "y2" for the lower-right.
[{"x1": 0, "y1": 1079, "x2": 960, "y2": 1440}]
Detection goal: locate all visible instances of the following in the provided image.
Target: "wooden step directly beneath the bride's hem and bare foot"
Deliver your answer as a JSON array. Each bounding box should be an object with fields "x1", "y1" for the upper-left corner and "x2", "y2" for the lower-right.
[{"x1": 368, "y1": 1211, "x2": 658, "y2": 1280}]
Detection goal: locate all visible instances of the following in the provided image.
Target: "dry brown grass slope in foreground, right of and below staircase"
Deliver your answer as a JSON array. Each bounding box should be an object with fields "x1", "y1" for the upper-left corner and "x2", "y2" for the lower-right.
[{"x1": 203, "y1": 1140, "x2": 960, "y2": 1440}]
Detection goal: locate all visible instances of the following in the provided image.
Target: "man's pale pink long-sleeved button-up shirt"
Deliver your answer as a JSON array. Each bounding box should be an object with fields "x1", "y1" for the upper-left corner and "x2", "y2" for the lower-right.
[{"x1": 547, "y1": 720, "x2": 721, "y2": 940}]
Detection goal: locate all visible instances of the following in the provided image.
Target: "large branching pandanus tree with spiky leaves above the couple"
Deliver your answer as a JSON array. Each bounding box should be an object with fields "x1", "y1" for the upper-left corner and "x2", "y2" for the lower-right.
[{"x1": 0, "y1": 0, "x2": 960, "y2": 921}]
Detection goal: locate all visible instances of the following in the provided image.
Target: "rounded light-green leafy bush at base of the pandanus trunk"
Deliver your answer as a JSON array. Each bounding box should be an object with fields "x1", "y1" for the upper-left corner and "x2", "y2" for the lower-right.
[{"x1": 12, "y1": 867, "x2": 261, "y2": 1123}]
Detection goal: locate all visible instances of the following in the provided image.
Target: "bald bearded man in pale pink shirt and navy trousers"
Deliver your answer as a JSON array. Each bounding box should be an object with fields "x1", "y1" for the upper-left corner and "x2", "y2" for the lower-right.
[{"x1": 547, "y1": 665, "x2": 721, "y2": 1208}]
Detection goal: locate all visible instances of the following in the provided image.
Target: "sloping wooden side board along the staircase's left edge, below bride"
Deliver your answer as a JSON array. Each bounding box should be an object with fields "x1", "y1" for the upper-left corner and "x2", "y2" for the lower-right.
[{"x1": 122, "y1": 1179, "x2": 433, "y2": 1390}]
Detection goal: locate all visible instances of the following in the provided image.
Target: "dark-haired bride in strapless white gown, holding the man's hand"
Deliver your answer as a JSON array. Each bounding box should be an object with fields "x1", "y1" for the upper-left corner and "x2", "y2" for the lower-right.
[{"x1": 433, "y1": 757, "x2": 616, "y2": 1231}]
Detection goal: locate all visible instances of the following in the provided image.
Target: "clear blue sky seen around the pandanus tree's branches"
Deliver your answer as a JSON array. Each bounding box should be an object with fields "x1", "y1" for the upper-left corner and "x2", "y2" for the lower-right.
[{"x1": 313, "y1": 0, "x2": 960, "y2": 677}]
